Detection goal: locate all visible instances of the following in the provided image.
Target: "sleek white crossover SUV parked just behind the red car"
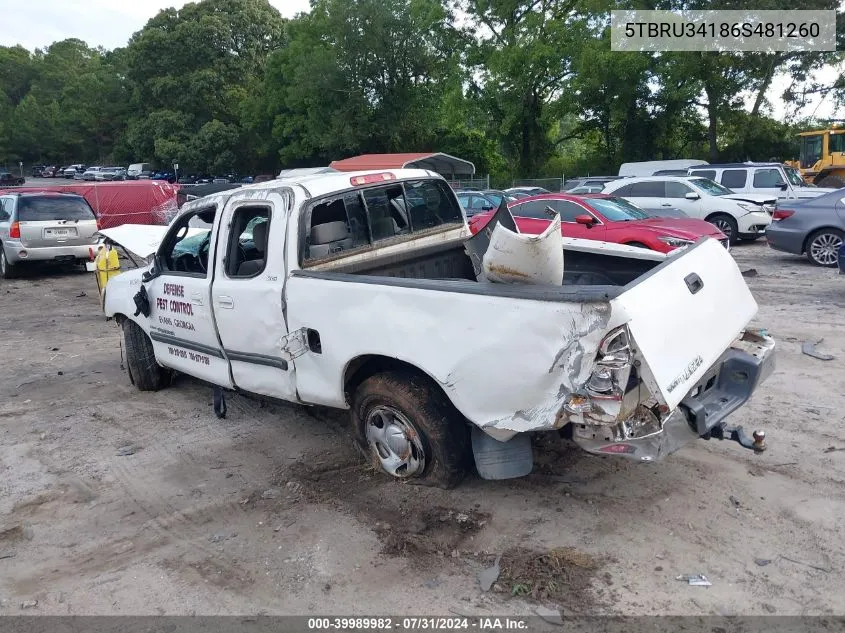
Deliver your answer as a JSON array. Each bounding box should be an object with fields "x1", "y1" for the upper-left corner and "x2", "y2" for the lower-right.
[{"x1": 602, "y1": 176, "x2": 777, "y2": 244}]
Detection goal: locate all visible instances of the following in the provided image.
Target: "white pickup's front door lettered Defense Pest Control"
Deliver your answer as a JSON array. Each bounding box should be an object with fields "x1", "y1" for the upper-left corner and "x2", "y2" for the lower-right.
[{"x1": 144, "y1": 206, "x2": 232, "y2": 387}]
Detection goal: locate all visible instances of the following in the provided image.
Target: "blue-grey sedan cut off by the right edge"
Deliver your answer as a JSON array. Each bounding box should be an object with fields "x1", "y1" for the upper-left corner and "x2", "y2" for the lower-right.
[{"x1": 766, "y1": 189, "x2": 845, "y2": 266}]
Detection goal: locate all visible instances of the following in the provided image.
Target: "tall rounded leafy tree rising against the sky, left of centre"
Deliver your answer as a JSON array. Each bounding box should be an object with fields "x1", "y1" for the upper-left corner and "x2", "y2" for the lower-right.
[{"x1": 125, "y1": 0, "x2": 285, "y2": 169}]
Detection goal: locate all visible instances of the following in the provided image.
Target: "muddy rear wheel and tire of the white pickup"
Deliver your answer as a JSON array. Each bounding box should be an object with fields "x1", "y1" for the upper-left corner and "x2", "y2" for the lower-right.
[{"x1": 351, "y1": 371, "x2": 470, "y2": 489}]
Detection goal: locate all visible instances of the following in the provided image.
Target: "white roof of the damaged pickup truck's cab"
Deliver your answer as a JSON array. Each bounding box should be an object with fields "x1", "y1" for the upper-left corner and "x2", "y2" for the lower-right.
[{"x1": 177, "y1": 169, "x2": 445, "y2": 217}]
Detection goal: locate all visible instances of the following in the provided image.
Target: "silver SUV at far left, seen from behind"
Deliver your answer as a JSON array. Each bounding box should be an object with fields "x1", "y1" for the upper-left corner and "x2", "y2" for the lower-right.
[{"x1": 0, "y1": 192, "x2": 97, "y2": 279}]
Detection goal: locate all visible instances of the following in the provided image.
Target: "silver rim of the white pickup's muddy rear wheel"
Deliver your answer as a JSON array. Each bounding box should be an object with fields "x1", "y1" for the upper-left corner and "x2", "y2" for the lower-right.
[{"x1": 366, "y1": 406, "x2": 425, "y2": 479}]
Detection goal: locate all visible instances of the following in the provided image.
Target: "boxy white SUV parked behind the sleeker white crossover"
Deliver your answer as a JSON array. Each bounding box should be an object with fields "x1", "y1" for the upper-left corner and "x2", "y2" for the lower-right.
[{"x1": 689, "y1": 163, "x2": 835, "y2": 200}]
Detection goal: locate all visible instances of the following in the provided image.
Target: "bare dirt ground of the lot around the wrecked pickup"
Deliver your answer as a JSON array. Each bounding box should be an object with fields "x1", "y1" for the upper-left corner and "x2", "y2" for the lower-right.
[{"x1": 0, "y1": 243, "x2": 845, "y2": 615}]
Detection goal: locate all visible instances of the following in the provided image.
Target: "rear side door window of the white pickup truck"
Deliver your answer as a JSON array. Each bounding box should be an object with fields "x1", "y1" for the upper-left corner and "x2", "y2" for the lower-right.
[{"x1": 226, "y1": 207, "x2": 270, "y2": 278}]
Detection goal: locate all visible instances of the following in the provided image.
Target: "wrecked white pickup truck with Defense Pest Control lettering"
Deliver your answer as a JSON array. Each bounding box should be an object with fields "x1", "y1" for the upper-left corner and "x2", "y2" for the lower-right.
[{"x1": 102, "y1": 170, "x2": 774, "y2": 487}]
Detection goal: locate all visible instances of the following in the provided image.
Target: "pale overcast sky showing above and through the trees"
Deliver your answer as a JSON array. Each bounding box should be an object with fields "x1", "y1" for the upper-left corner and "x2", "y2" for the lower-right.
[{"x1": 0, "y1": 0, "x2": 845, "y2": 119}]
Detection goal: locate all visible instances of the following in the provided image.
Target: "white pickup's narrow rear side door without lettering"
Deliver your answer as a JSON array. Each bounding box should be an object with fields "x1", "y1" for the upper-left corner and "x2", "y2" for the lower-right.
[{"x1": 211, "y1": 192, "x2": 297, "y2": 400}]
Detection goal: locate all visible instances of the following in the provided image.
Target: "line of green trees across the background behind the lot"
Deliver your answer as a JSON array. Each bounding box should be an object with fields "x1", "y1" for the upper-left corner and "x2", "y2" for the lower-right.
[{"x1": 0, "y1": 0, "x2": 845, "y2": 181}]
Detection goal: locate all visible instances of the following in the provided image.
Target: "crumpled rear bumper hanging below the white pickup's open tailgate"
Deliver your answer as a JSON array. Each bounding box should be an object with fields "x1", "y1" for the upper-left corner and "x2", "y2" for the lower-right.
[{"x1": 573, "y1": 330, "x2": 775, "y2": 462}]
